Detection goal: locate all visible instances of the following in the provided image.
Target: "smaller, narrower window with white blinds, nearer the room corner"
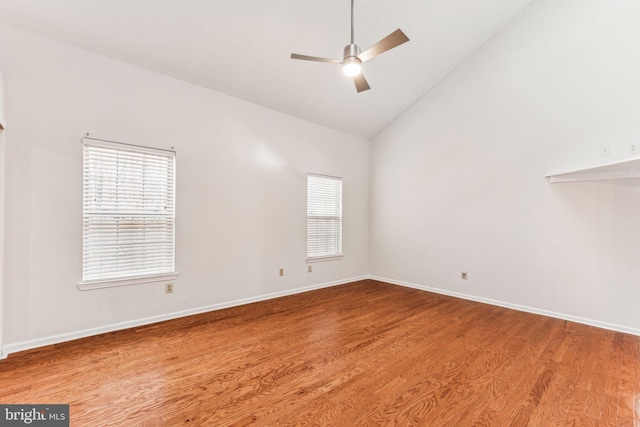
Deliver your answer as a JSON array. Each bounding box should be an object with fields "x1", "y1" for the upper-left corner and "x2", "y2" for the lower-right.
[{"x1": 307, "y1": 174, "x2": 342, "y2": 262}]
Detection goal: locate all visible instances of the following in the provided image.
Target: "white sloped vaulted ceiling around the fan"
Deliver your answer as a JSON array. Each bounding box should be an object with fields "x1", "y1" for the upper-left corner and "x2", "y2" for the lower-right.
[{"x1": 0, "y1": 0, "x2": 532, "y2": 138}]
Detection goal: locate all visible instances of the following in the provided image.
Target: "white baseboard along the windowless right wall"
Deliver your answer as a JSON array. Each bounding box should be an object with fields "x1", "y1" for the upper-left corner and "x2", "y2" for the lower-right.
[{"x1": 369, "y1": 275, "x2": 640, "y2": 336}]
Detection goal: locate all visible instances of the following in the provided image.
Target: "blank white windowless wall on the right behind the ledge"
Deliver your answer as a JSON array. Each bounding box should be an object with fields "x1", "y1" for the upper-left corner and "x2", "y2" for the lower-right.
[{"x1": 370, "y1": 0, "x2": 640, "y2": 334}]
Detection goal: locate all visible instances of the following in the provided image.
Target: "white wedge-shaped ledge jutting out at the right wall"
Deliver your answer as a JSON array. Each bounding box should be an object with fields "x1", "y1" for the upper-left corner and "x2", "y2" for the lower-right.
[{"x1": 546, "y1": 157, "x2": 640, "y2": 183}]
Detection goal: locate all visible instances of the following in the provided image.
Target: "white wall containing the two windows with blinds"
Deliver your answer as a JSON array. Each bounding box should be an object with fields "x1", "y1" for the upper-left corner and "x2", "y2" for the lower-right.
[{"x1": 0, "y1": 20, "x2": 369, "y2": 351}]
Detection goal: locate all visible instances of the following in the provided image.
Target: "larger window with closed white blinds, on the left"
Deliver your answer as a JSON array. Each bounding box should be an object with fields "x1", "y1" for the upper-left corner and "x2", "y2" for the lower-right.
[{"x1": 80, "y1": 138, "x2": 176, "y2": 289}]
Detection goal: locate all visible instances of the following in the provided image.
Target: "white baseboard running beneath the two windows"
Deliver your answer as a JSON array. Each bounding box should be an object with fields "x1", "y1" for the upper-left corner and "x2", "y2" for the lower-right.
[{"x1": 0, "y1": 276, "x2": 368, "y2": 359}]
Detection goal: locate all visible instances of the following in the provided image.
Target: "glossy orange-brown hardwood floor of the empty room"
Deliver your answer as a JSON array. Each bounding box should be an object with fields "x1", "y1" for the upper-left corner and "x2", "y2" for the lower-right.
[{"x1": 0, "y1": 280, "x2": 640, "y2": 427}]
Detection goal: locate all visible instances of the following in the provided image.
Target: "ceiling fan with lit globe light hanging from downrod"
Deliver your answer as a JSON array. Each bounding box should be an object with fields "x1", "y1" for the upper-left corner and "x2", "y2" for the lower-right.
[{"x1": 291, "y1": 0, "x2": 409, "y2": 93}]
